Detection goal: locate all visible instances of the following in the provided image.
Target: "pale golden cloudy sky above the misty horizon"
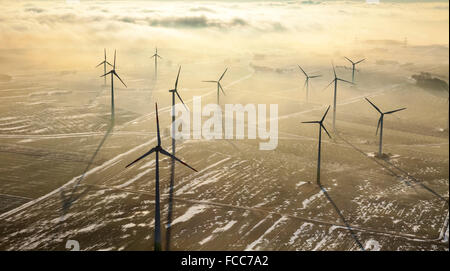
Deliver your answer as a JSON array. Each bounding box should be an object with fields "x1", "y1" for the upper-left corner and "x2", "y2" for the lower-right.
[{"x1": 0, "y1": 1, "x2": 449, "y2": 49}]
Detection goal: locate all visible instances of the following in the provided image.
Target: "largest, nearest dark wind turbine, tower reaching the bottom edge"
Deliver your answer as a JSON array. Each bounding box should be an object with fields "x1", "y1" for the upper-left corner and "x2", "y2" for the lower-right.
[{"x1": 126, "y1": 103, "x2": 197, "y2": 251}]
